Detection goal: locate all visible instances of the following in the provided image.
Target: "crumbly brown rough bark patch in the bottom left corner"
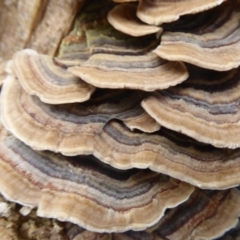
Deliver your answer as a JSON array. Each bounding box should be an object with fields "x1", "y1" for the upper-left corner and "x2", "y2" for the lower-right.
[{"x1": 0, "y1": 195, "x2": 79, "y2": 240}]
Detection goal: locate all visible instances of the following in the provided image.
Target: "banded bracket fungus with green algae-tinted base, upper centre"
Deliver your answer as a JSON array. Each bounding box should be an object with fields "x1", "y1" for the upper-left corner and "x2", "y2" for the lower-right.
[{"x1": 68, "y1": 3, "x2": 188, "y2": 91}]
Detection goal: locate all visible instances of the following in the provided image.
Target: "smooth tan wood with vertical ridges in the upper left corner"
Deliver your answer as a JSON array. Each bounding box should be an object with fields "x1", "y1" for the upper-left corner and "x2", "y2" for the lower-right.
[{"x1": 0, "y1": 0, "x2": 84, "y2": 82}]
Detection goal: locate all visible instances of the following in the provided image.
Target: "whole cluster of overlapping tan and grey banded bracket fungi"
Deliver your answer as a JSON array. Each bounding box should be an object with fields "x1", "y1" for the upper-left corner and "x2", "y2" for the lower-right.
[{"x1": 0, "y1": 0, "x2": 240, "y2": 240}]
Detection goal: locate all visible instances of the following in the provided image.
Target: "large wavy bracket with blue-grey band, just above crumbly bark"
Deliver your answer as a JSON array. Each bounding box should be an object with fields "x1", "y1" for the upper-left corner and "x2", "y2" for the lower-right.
[{"x1": 0, "y1": 123, "x2": 194, "y2": 232}]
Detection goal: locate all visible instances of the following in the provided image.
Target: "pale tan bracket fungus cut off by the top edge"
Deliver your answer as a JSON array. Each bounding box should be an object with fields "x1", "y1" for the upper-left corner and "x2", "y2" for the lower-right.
[{"x1": 137, "y1": 0, "x2": 225, "y2": 25}]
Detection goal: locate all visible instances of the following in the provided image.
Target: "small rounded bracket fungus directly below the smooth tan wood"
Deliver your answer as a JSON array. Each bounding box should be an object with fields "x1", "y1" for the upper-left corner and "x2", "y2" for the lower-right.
[{"x1": 13, "y1": 49, "x2": 95, "y2": 104}]
